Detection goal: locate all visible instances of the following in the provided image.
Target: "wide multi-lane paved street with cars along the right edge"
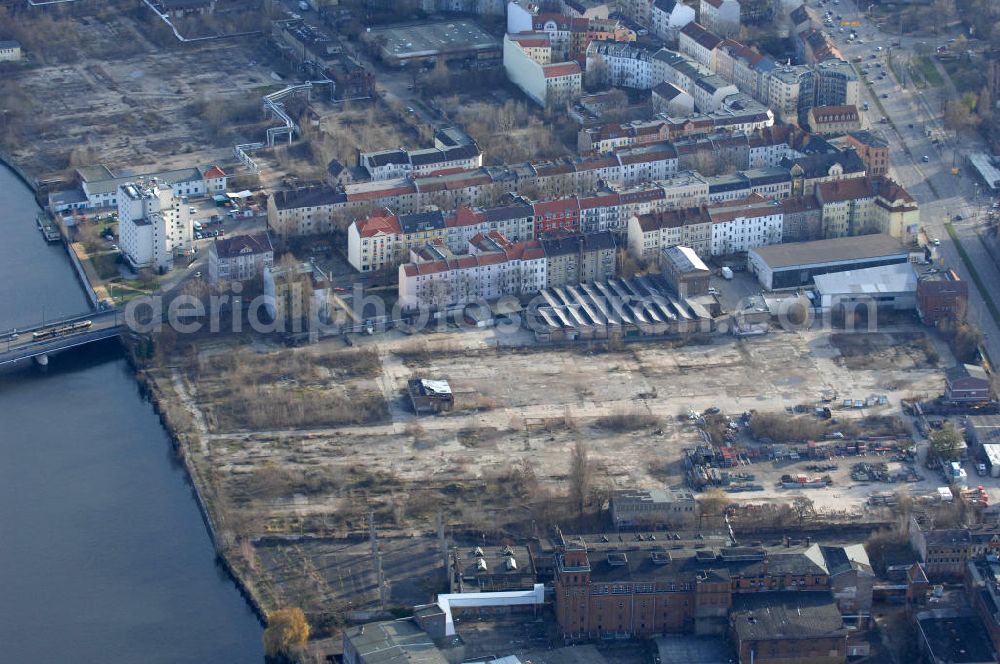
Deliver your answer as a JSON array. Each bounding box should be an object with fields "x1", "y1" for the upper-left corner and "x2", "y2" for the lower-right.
[{"x1": 808, "y1": 0, "x2": 1000, "y2": 361}]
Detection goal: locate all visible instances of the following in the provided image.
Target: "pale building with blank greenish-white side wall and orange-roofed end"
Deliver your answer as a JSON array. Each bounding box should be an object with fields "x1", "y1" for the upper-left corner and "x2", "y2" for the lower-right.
[{"x1": 503, "y1": 34, "x2": 583, "y2": 108}]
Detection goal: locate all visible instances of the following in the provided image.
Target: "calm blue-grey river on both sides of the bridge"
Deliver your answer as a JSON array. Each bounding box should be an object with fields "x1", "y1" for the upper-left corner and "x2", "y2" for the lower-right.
[{"x1": 0, "y1": 166, "x2": 263, "y2": 664}]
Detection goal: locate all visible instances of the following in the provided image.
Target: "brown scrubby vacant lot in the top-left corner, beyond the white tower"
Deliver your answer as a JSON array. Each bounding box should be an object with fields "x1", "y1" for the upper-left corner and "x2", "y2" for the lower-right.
[{"x1": 4, "y1": 14, "x2": 275, "y2": 179}]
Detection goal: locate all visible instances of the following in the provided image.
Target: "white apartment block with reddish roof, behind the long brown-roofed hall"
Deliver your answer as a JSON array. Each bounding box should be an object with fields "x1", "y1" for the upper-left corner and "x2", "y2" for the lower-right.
[{"x1": 708, "y1": 194, "x2": 784, "y2": 256}]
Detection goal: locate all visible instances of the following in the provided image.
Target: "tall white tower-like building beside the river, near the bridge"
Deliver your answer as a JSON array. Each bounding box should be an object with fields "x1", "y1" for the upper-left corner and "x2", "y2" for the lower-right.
[{"x1": 115, "y1": 178, "x2": 193, "y2": 272}]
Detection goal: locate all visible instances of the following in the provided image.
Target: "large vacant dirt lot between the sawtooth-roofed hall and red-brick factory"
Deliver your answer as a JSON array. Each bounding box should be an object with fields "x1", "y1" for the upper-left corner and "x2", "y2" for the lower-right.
[{"x1": 150, "y1": 326, "x2": 968, "y2": 608}]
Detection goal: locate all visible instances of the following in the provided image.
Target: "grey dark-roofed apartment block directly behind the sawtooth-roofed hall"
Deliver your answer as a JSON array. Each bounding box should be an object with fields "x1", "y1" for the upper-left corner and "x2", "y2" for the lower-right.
[{"x1": 541, "y1": 231, "x2": 617, "y2": 288}]
